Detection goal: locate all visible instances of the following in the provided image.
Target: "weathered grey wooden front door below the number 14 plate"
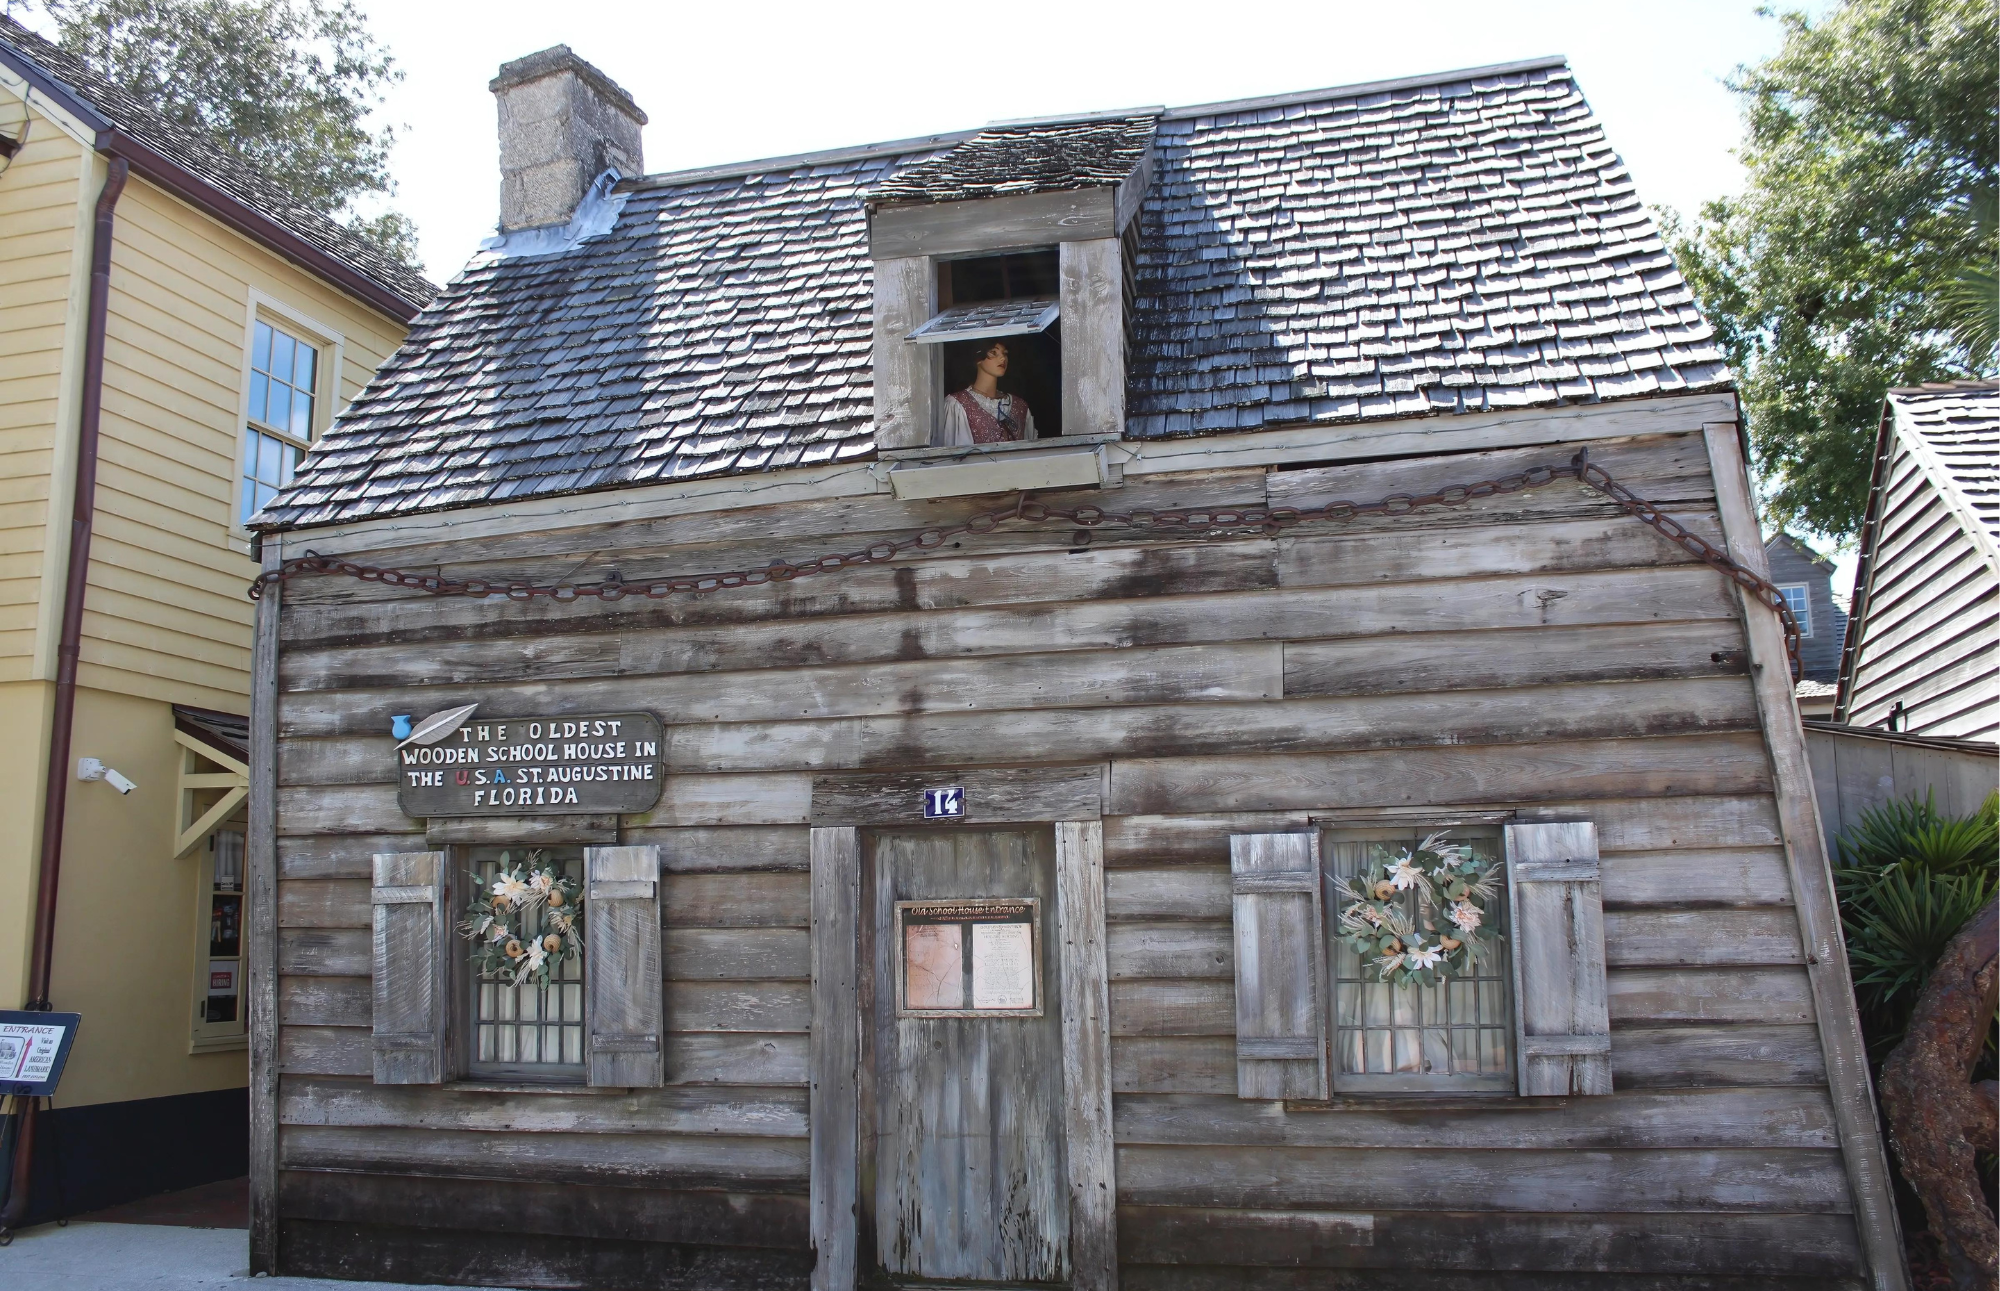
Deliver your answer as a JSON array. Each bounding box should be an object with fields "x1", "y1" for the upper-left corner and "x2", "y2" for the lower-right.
[{"x1": 860, "y1": 827, "x2": 1070, "y2": 1285}]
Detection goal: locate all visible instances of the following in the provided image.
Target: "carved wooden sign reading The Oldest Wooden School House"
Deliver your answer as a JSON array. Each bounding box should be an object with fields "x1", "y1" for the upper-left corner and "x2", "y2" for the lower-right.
[{"x1": 396, "y1": 713, "x2": 662, "y2": 815}]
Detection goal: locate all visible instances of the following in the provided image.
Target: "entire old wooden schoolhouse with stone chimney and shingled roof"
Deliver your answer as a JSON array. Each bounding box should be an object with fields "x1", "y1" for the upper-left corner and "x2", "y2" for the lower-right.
[{"x1": 248, "y1": 48, "x2": 1906, "y2": 1291}]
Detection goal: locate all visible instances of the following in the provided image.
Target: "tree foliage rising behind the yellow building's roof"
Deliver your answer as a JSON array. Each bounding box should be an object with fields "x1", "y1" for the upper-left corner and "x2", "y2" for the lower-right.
[{"x1": 10, "y1": 0, "x2": 416, "y2": 264}]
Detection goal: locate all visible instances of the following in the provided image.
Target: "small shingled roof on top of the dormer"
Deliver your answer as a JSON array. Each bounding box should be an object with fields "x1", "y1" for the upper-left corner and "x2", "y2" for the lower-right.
[{"x1": 868, "y1": 108, "x2": 1162, "y2": 204}]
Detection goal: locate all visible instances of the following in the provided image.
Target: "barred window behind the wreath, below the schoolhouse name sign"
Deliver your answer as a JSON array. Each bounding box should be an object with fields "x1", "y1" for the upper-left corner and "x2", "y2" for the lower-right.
[{"x1": 466, "y1": 847, "x2": 590, "y2": 1081}]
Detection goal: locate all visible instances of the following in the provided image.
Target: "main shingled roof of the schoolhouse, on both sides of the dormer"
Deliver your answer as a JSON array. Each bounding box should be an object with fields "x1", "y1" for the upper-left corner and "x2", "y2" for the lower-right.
[{"x1": 258, "y1": 60, "x2": 1730, "y2": 528}]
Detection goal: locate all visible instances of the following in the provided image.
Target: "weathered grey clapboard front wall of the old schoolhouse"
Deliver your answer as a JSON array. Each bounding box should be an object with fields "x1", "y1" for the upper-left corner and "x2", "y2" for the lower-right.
[{"x1": 276, "y1": 428, "x2": 1860, "y2": 1291}]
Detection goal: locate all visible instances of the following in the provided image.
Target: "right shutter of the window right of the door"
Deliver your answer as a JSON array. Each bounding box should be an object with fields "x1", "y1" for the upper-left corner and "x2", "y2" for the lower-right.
[{"x1": 1506, "y1": 821, "x2": 1612, "y2": 1095}]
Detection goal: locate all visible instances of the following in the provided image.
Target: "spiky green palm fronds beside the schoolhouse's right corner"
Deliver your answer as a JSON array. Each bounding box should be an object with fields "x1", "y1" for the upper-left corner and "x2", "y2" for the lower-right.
[{"x1": 1834, "y1": 793, "x2": 2000, "y2": 1059}]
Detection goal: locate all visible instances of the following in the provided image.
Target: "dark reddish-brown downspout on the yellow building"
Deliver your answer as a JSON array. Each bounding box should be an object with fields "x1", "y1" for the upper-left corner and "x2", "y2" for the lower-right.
[{"x1": 0, "y1": 156, "x2": 130, "y2": 1235}]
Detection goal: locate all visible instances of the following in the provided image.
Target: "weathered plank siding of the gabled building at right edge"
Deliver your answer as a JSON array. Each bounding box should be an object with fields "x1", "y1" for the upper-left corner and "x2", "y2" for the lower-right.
[{"x1": 1840, "y1": 430, "x2": 2000, "y2": 739}]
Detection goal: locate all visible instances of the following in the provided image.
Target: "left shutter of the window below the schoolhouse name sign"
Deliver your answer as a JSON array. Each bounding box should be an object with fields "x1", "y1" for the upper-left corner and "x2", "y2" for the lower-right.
[{"x1": 368, "y1": 851, "x2": 450, "y2": 1085}]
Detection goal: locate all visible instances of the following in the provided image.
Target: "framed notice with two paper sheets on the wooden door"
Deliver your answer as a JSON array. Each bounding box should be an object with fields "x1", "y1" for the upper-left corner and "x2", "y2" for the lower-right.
[{"x1": 896, "y1": 897, "x2": 1042, "y2": 1017}]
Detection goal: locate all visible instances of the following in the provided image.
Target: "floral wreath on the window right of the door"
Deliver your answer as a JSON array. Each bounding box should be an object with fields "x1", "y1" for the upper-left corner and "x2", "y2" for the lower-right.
[{"x1": 1334, "y1": 829, "x2": 1504, "y2": 985}]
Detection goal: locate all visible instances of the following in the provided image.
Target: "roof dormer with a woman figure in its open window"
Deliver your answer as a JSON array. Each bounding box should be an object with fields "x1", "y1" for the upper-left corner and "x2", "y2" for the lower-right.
[{"x1": 868, "y1": 112, "x2": 1158, "y2": 452}]
